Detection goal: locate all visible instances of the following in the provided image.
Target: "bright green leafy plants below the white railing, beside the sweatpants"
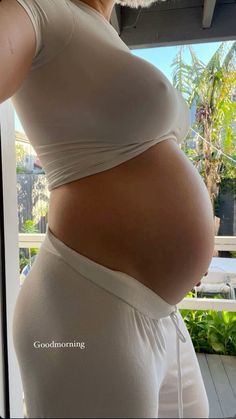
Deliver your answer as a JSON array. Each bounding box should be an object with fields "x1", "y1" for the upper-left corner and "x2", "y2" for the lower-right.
[{"x1": 179, "y1": 309, "x2": 236, "y2": 356}]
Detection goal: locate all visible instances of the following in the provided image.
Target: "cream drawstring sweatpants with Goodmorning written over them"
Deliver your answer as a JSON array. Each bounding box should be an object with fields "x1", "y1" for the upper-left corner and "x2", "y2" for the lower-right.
[{"x1": 13, "y1": 227, "x2": 209, "y2": 418}]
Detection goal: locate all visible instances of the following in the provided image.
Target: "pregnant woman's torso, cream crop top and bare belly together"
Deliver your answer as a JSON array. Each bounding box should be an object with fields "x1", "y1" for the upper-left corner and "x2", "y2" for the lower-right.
[{"x1": 13, "y1": 0, "x2": 216, "y2": 303}]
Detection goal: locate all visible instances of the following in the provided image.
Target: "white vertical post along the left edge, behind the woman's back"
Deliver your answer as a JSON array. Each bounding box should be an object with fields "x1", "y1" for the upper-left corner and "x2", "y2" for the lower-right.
[{"x1": 0, "y1": 99, "x2": 24, "y2": 418}]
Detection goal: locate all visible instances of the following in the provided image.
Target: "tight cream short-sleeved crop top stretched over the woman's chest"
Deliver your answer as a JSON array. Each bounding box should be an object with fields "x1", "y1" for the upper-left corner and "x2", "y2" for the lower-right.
[{"x1": 11, "y1": 0, "x2": 190, "y2": 191}]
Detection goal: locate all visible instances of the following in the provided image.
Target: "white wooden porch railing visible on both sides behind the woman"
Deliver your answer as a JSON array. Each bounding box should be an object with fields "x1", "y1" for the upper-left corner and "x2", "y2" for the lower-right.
[{"x1": 18, "y1": 233, "x2": 236, "y2": 312}]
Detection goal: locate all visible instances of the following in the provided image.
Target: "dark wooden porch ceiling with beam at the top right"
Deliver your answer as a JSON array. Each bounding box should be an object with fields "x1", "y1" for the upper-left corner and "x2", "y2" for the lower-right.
[{"x1": 111, "y1": 0, "x2": 236, "y2": 49}]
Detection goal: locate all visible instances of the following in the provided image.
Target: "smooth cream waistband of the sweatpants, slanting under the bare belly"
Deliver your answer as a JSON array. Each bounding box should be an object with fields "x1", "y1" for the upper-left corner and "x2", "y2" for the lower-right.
[{"x1": 41, "y1": 224, "x2": 176, "y2": 320}]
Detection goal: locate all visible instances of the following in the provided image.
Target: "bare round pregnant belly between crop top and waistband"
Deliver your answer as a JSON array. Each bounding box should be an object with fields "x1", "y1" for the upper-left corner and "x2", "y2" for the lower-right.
[{"x1": 48, "y1": 139, "x2": 214, "y2": 304}]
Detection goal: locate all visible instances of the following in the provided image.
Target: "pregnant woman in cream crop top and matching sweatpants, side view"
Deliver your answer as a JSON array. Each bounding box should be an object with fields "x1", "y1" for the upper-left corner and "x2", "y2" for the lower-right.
[{"x1": 0, "y1": 0, "x2": 214, "y2": 418}]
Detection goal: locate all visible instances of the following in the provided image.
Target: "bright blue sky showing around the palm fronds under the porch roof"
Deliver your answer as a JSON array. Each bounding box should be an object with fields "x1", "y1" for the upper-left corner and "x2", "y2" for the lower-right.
[{"x1": 15, "y1": 41, "x2": 234, "y2": 133}]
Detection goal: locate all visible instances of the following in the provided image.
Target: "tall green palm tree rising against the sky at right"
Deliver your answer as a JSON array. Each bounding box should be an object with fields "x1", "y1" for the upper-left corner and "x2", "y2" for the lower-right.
[{"x1": 172, "y1": 42, "x2": 236, "y2": 205}]
